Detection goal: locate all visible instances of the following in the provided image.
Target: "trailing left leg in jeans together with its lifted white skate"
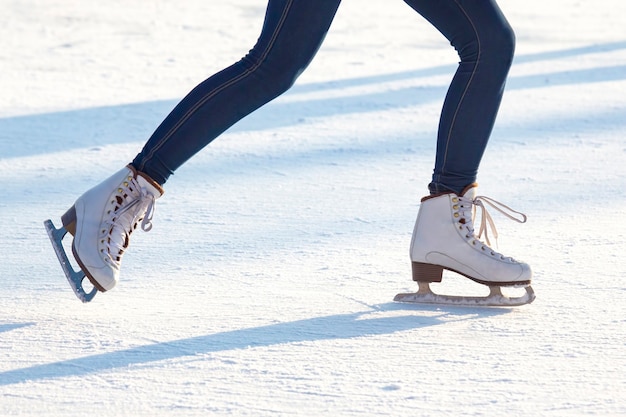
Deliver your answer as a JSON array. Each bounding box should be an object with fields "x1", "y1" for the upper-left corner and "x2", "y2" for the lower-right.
[{"x1": 56, "y1": 0, "x2": 341, "y2": 294}]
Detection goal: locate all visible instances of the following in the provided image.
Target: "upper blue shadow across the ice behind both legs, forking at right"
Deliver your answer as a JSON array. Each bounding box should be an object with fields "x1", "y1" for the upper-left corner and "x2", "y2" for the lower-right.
[{"x1": 0, "y1": 41, "x2": 626, "y2": 159}]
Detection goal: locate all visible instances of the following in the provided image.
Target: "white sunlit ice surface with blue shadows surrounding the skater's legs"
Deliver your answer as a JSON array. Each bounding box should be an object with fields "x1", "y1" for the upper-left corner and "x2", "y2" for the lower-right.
[{"x1": 0, "y1": 0, "x2": 626, "y2": 417}]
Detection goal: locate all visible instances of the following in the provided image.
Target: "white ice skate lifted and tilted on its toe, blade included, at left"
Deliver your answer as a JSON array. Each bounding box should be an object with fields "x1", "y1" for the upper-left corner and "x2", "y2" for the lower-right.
[{"x1": 44, "y1": 165, "x2": 163, "y2": 302}]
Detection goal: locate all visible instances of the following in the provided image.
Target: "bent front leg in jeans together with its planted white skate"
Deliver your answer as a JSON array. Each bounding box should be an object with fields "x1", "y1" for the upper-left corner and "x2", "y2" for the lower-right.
[{"x1": 402, "y1": 0, "x2": 535, "y2": 306}]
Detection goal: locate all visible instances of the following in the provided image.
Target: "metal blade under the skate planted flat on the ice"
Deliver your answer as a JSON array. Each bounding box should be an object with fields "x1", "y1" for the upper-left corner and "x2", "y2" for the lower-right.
[{"x1": 393, "y1": 282, "x2": 535, "y2": 307}]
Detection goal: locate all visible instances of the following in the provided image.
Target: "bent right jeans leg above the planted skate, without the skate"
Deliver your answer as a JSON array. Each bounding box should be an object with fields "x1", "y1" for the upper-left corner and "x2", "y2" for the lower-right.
[{"x1": 405, "y1": 0, "x2": 515, "y2": 194}]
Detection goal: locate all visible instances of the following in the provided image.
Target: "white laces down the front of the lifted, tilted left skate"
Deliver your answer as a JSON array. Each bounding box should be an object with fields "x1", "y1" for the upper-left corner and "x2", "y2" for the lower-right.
[{"x1": 100, "y1": 176, "x2": 155, "y2": 268}]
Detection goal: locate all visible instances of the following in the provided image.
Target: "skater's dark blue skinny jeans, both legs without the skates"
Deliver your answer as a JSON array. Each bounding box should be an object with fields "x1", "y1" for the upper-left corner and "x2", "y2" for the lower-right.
[{"x1": 132, "y1": 0, "x2": 515, "y2": 194}]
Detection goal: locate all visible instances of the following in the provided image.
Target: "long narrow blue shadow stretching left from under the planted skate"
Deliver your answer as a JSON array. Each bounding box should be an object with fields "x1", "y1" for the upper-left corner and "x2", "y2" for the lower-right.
[{"x1": 0, "y1": 303, "x2": 510, "y2": 385}]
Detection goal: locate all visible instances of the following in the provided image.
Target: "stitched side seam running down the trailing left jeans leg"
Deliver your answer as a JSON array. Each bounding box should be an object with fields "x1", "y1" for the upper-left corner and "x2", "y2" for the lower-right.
[{"x1": 137, "y1": 0, "x2": 293, "y2": 171}]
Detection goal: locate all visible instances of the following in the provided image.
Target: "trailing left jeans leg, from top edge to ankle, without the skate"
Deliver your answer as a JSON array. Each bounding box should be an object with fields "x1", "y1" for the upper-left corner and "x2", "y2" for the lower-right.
[{"x1": 132, "y1": 0, "x2": 341, "y2": 185}]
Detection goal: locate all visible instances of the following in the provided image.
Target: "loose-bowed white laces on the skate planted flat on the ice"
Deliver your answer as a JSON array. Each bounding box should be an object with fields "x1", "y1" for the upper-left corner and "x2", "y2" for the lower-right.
[{"x1": 459, "y1": 196, "x2": 527, "y2": 259}]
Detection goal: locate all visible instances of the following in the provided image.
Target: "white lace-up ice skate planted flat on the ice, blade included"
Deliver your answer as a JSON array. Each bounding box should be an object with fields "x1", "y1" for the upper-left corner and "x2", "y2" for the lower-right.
[{"x1": 394, "y1": 184, "x2": 535, "y2": 306}]
